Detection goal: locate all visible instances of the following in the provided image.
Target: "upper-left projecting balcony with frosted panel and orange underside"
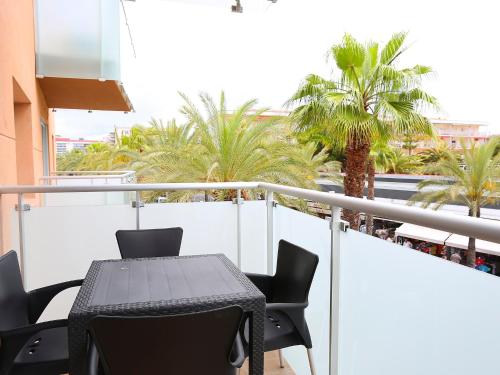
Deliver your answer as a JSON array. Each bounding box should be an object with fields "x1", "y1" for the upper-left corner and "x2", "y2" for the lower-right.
[{"x1": 35, "y1": 0, "x2": 133, "y2": 111}]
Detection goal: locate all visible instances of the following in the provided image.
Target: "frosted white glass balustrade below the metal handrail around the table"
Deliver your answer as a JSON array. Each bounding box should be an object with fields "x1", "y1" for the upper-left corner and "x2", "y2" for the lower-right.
[{"x1": 8, "y1": 201, "x2": 500, "y2": 375}]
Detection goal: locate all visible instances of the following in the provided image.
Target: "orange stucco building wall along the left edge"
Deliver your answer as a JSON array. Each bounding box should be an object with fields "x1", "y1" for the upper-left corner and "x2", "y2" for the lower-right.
[{"x1": 0, "y1": 0, "x2": 55, "y2": 253}]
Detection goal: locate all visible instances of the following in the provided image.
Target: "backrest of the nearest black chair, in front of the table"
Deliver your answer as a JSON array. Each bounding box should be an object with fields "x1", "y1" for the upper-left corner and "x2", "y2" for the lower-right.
[{"x1": 89, "y1": 306, "x2": 243, "y2": 375}]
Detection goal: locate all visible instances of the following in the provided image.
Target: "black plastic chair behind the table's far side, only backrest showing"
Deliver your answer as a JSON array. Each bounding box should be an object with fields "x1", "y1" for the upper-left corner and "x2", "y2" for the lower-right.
[{"x1": 116, "y1": 228, "x2": 182, "y2": 259}]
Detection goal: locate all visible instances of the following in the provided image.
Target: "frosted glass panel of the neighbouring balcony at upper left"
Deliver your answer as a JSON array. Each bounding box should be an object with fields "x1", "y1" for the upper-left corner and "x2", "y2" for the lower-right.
[{"x1": 35, "y1": 0, "x2": 120, "y2": 81}]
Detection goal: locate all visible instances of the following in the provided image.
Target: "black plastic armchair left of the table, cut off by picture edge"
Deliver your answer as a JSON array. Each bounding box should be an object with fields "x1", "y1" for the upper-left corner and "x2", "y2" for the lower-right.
[{"x1": 0, "y1": 251, "x2": 83, "y2": 375}]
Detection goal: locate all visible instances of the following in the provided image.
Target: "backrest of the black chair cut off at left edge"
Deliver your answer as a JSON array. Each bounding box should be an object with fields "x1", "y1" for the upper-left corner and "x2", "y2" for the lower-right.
[{"x1": 0, "y1": 250, "x2": 29, "y2": 331}]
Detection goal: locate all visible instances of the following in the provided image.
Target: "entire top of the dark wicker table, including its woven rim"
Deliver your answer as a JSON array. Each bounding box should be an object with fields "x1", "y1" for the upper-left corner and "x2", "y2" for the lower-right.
[{"x1": 70, "y1": 254, "x2": 261, "y2": 315}]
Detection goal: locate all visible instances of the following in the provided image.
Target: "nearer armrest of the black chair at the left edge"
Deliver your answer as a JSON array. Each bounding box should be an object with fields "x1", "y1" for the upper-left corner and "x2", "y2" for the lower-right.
[{"x1": 0, "y1": 319, "x2": 68, "y2": 368}]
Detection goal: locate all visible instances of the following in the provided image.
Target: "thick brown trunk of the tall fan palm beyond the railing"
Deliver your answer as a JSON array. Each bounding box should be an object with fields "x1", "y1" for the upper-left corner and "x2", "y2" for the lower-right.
[{"x1": 343, "y1": 139, "x2": 370, "y2": 230}]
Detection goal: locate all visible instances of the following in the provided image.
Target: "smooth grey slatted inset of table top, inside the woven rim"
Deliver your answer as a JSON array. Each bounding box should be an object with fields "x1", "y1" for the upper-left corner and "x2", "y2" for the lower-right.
[{"x1": 89, "y1": 255, "x2": 246, "y2": 306}]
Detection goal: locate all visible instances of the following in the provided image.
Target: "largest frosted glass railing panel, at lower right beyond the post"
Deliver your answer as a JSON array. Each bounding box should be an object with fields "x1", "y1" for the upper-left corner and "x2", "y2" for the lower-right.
[{"x1": 339, "y1": 230, "x2": 500, "y2": 375}]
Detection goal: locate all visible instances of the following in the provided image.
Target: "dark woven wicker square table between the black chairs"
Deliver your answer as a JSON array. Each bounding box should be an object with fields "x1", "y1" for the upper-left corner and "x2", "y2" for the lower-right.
[{"x1": 68, "y1": 254, "x2": 265, "y2": 375}]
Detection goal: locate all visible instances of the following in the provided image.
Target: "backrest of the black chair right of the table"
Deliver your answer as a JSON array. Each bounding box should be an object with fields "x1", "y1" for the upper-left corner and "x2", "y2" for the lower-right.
[{"x1": 272, "y1": 240, "x2": 319, "y2": 303}]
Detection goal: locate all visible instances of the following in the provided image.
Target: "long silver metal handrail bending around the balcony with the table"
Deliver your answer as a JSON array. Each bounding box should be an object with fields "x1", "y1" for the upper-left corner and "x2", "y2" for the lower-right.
[{"x1": 0, "y1": 182, "x2": 500, "y2": 243}]
